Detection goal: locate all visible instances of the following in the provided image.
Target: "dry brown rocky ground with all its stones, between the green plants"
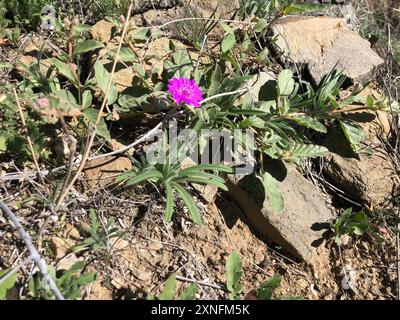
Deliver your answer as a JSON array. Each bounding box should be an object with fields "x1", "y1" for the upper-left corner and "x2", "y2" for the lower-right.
[{"x1": 0, "y1": 0, "x2": 400, "y2": 300}]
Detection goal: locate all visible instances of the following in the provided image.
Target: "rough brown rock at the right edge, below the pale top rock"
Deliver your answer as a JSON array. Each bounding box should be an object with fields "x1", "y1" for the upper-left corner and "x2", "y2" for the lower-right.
[{"x1": 323, "y1": 127, "x2": 399, "y2": 209}]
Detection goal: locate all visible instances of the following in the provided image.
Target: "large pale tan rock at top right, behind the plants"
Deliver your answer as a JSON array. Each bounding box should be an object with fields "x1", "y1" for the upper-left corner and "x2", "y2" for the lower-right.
[{"x1": 272, "y1": 16, "x2": 383, "y2": 84}]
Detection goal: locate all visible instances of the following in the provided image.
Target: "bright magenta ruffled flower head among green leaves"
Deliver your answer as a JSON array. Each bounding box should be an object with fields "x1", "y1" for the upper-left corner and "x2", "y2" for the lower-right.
[{"x1": 168, "y1": 77, "x2": 204, "y2": 107}]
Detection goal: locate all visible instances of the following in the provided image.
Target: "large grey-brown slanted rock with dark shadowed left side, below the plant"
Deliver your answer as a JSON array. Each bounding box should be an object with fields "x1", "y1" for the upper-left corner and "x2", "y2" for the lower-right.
[{"x1": 227, "y1": 161, "x2": 334, "y2": 263}]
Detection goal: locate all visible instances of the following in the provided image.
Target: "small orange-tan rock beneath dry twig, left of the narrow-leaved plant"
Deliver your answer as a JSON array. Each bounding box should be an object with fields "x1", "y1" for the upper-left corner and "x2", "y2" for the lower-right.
[{"x1": 84, "y1": 157, "x2": 132, "y2": 189}]
